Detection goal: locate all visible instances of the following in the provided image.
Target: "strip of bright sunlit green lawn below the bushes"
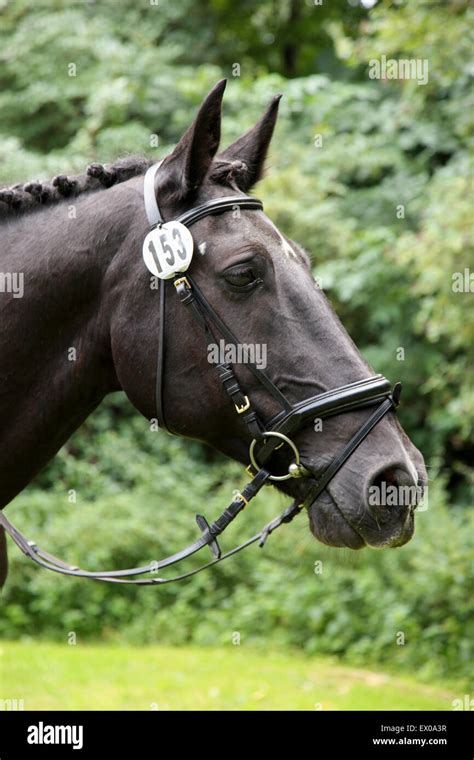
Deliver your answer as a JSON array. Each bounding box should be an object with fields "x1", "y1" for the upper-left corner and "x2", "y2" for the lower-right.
[{"x1": 0, "y1": 642, "x2": 458, "y2": 710}]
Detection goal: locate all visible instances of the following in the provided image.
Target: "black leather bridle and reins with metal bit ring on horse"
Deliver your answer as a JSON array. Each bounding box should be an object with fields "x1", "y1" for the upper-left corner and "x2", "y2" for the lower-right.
[{"x1": 0, "y1": 162, "x2": 401, "y2": 586}]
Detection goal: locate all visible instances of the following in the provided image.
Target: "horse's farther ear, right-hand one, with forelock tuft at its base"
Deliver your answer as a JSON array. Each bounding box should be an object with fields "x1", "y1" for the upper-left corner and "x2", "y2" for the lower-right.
[{"x1": 217, "y1": 95, "x2": 281, "y2": 193}]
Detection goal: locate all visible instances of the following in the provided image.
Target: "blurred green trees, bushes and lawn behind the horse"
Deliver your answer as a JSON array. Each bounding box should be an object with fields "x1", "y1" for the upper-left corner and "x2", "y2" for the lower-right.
[{"x1": 0, "y1": 0, "x2": 474, "y2": 709}]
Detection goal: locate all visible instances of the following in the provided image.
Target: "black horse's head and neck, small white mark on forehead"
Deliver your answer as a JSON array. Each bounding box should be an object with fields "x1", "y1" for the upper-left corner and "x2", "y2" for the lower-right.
[{"x1": 0, "y1": 82, "x2": 426, "y2": 580}]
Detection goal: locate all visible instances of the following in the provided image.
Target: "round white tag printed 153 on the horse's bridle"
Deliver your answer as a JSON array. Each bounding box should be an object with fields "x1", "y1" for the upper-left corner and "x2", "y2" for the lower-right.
[{"x1": 143, "y1": 222, "x2": 194, "y2": 280}]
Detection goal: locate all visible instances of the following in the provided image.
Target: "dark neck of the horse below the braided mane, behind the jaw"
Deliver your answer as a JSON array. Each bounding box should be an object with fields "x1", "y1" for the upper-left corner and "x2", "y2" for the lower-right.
[{"x1": 0, "y1": 185, "x2": 135, "y2": 507}]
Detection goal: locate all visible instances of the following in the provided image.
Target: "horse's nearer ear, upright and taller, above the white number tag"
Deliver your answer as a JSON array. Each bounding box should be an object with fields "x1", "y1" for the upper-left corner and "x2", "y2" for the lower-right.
[{"x1": 163, "y1": 79, "x2": 227, "y2": 199}]
